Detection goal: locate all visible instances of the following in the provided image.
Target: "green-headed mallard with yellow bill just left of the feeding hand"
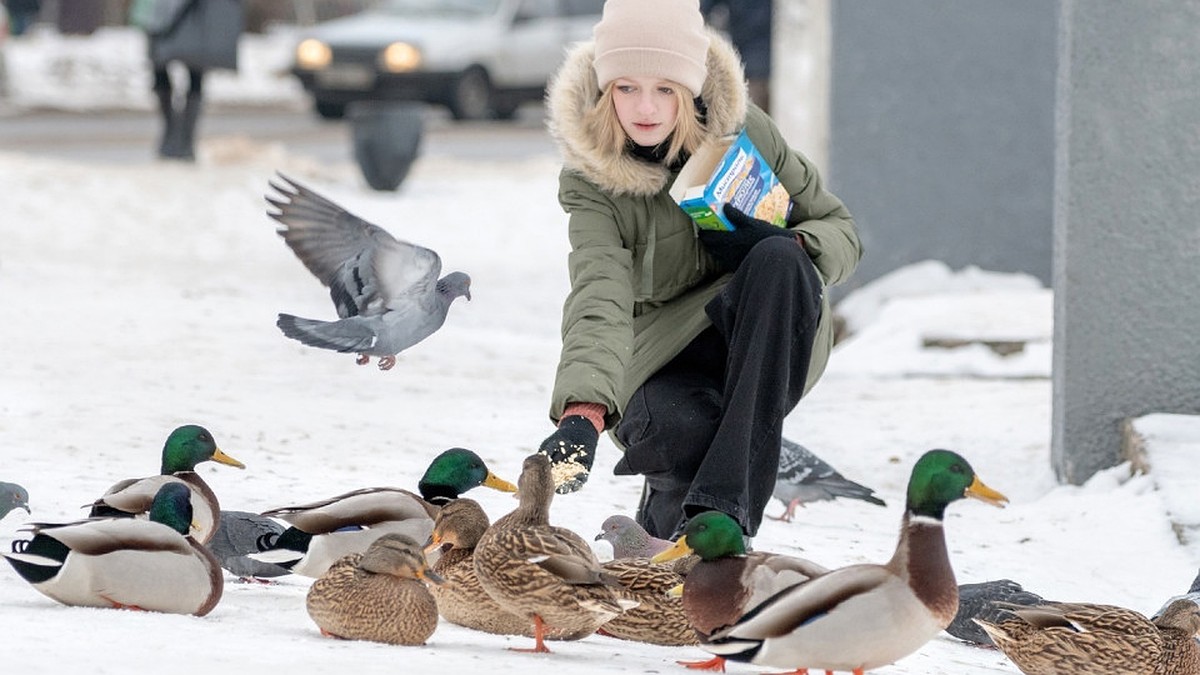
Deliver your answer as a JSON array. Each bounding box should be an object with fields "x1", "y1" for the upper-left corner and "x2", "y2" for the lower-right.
[{"x1": 250, "y1": 448, "x2": 516, "y2": 578}]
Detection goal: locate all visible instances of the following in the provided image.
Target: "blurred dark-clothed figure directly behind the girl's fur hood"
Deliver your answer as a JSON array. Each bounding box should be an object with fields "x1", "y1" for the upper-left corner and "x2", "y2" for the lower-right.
[{"x1": 700, "y1": 0, "x2": 774, "y2": 112}]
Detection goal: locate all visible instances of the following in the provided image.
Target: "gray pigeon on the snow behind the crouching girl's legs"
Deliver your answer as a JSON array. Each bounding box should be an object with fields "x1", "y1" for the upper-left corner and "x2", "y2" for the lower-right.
[{"x1": 767, "y1": 438, "x2": 887, "y2": 522}]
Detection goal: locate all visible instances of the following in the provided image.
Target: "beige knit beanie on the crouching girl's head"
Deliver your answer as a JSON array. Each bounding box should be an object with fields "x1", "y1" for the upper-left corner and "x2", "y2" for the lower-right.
[{"x1": 593, "y1": 0, "x2": 708, "y2": 96}]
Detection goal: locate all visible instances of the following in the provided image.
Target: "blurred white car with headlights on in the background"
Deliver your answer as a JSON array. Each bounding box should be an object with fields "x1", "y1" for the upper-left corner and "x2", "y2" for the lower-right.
[{"x1": 293, "y1": 0, "x2": 604, "y2": 119}]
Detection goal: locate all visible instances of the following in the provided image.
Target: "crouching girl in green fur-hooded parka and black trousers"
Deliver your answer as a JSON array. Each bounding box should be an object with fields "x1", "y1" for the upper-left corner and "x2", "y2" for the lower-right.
[{"x1": 540, "y1": 0, "x2": 862, "y2": 538}]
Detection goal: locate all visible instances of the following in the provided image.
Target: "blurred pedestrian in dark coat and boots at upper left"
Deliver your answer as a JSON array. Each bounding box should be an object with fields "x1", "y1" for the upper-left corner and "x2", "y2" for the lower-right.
[{"x1": 131, "y1": 0, "x2": 244, "y2": 161}]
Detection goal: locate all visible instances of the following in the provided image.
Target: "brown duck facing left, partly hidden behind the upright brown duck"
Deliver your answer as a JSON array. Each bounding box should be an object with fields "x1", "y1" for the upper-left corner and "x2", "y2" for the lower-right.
[{"x1": 430, "y1": 497, "x2": 589, "y2": 640}]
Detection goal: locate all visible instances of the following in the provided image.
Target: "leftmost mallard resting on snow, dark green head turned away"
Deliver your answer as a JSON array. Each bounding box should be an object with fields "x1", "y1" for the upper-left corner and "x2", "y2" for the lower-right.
[{"x1": 2, "y1": 482, "x2": 224, "y2": 616}]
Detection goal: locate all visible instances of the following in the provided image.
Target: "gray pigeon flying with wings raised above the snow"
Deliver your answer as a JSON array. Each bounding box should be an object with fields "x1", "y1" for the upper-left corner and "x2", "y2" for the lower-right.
[{"x1": 266, "y1": 174, "x2": 470, "y2": 370}]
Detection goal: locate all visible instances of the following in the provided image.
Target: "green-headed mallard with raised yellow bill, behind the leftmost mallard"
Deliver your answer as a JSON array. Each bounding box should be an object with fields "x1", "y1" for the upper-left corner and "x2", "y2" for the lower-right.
[{"x1": 89, "y1": 424, "x2": 246, "y2": 544}]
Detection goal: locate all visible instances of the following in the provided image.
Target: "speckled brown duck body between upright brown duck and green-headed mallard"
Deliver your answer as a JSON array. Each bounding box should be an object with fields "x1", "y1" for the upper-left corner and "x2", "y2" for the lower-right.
[{"x1": 600, "y1": 557, "x2": 700, "y2": 646}]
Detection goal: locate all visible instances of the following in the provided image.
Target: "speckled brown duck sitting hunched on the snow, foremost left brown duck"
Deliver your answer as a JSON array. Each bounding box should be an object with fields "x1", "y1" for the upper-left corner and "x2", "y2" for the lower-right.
[{"x1": 306, "y1": 534, "x2": 438, "y2": 645}]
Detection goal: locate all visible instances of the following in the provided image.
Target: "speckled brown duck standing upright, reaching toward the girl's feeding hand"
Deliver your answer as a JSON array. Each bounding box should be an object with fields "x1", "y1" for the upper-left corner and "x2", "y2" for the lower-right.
[{"x1": 474, "y1": 454, "x2": 632, "y2": 652}]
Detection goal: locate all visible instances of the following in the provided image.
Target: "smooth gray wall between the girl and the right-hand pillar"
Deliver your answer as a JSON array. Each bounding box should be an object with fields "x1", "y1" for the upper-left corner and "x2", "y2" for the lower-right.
[{"x1": 827, "y1": 0, "x2": 1057, "y2": 297}]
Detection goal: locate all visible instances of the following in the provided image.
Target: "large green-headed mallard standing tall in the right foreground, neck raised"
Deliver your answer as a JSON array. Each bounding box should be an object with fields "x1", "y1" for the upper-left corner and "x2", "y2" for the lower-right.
[{"x1": 662, "y1": 449, "x2": 1008, "y2": 675}]
